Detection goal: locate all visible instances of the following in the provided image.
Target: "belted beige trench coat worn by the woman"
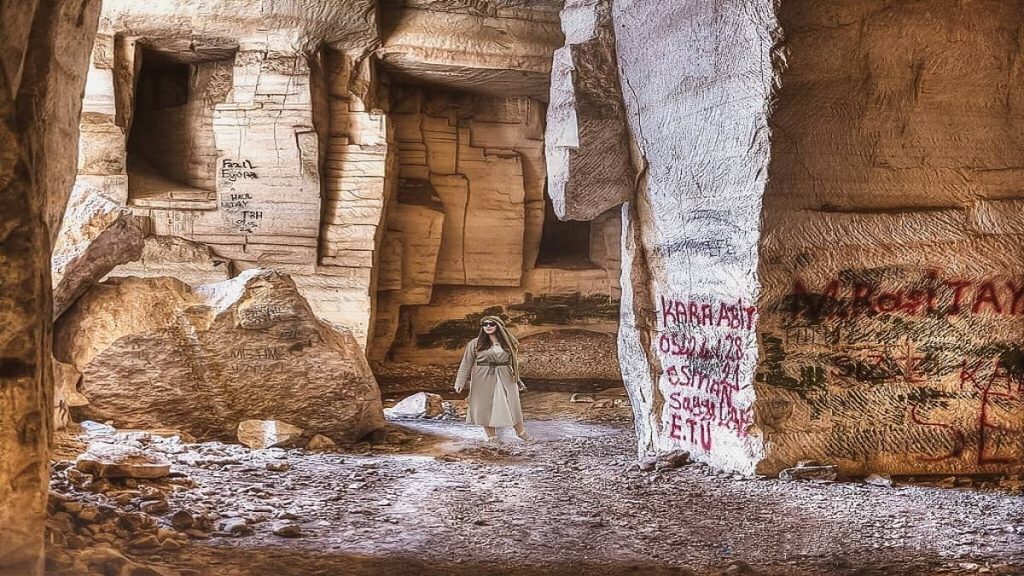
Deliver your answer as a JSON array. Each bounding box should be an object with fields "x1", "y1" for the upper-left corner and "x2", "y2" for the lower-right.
[{"x1": 455, "y1": 338, "x2": 522, "y2": 426}]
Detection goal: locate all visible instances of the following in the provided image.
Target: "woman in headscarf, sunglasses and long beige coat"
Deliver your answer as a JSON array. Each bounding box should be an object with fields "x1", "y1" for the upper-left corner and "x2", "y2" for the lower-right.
[{"x1": 455, "y1": 316, "x2": 532, "y2": 443}]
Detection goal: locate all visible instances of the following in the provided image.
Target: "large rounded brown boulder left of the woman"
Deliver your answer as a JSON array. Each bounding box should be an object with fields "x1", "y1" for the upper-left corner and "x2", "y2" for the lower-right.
[{"x1": 54, "y1": 270, "x2": 384, "y2": 442}]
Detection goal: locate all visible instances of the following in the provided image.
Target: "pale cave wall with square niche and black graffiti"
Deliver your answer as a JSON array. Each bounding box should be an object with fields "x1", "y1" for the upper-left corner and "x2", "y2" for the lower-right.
[{"x1": 79, "y1": 0, "x2": 389, "y2": 343}]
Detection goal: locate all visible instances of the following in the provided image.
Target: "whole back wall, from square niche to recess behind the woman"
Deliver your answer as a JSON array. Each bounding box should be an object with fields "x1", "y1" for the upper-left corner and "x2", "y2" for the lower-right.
[{"x1": 79, "y1": 0, "x2": 632, "y2": 385}]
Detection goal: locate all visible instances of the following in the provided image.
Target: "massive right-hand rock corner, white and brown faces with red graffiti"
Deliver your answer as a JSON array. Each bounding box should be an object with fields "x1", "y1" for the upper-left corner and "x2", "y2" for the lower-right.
[{"x1": 598, "y1": 0, "x2": 1024, "y2": 475}]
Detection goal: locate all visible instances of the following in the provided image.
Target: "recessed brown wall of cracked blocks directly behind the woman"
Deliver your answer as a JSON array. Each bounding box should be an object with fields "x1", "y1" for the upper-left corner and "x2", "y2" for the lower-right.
[{"x1": 371, "y1": 83, "x2": 620, "y2": 373}]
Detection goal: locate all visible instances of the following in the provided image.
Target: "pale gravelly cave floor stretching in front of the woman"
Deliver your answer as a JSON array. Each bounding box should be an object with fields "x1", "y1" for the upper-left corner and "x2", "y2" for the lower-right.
[{"x1": 50, "y1": 390, "x2": 1024, "y2": 576}]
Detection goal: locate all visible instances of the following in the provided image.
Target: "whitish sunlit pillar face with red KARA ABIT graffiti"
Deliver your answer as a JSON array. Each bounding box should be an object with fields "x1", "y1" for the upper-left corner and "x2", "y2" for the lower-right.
[{"x1": 612, "y1": 0, "x2": 775, "y2": 472}]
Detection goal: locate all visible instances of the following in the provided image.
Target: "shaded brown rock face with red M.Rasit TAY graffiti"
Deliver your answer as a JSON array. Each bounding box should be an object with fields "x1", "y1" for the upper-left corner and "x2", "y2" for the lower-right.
[{"x1": 755, "y1": 1, "x2": 1024, "y2": 475}]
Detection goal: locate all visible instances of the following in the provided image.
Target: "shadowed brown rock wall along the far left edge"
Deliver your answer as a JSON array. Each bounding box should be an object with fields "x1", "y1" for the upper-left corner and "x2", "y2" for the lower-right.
[{"x1": 0, "y1": 0, "x2": 99, "y2": 576}]
